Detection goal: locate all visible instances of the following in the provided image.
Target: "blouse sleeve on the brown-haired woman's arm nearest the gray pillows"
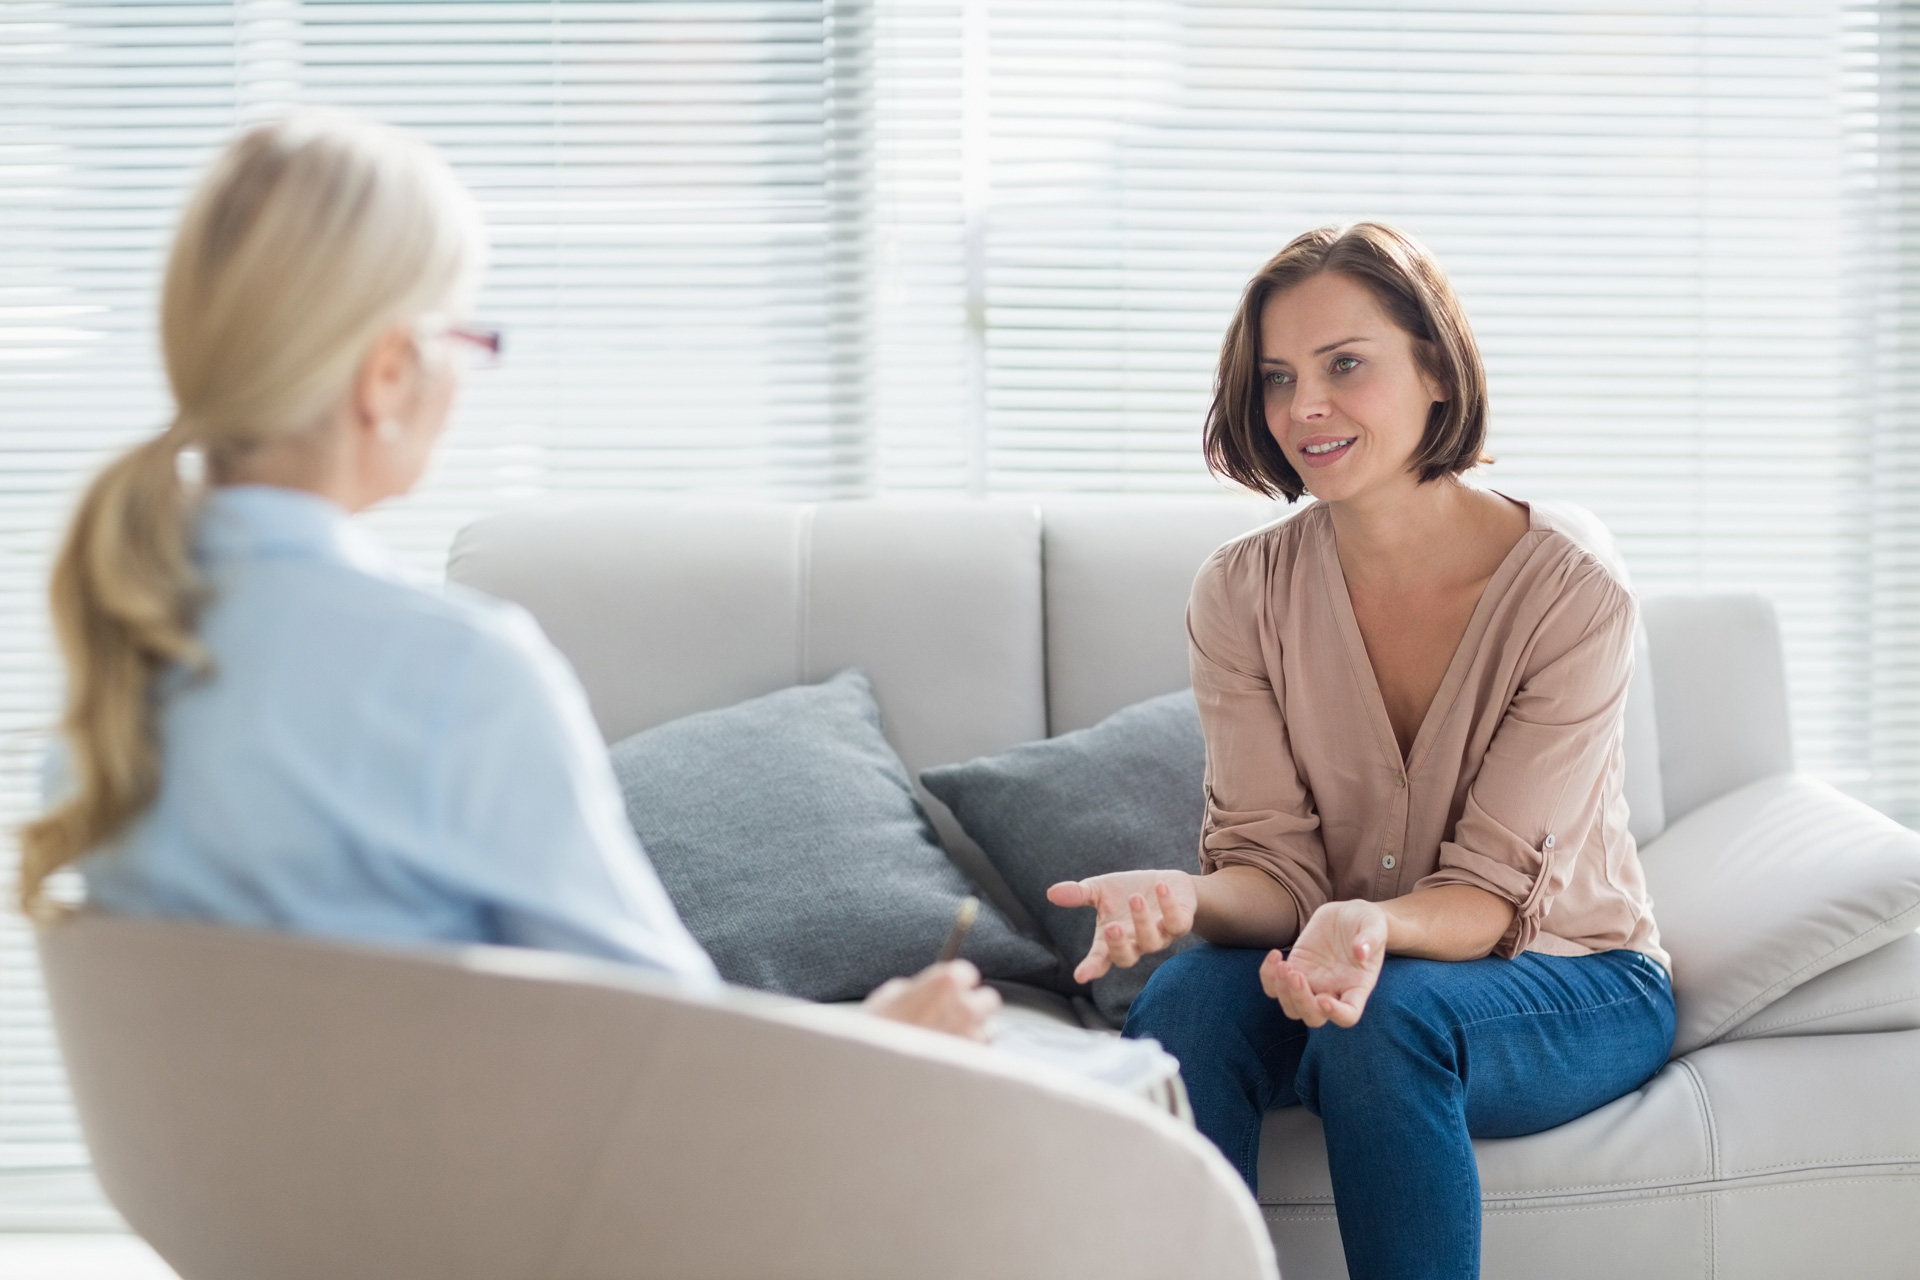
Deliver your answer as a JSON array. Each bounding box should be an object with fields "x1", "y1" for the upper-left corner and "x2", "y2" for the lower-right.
[{"x1": 1187, "y1": 545, "x2": 1331, "y2": 925}]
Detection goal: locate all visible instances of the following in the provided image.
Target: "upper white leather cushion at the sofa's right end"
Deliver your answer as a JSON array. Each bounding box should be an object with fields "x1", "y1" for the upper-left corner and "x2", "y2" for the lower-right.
[{"x1": 1642, "y1": 773, "x2": 1920, "y2": 1055}]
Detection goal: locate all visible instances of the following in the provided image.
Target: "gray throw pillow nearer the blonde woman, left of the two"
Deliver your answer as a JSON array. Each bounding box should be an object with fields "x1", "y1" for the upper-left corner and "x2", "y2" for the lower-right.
[{"x1": 612, "y1": 670, "x2": 1054, "y2": 1000}]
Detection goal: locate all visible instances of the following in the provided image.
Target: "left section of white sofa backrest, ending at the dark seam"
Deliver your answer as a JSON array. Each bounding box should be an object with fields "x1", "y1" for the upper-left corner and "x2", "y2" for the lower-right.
[{"x1": 447, "y1": 503, "x2": 1046, "y2": 773}]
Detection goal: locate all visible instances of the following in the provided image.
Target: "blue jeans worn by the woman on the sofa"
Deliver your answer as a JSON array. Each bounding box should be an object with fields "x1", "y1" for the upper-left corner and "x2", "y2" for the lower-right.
[{"x1": 1125, "y1": 942, "x2": 1674, "y2": 1280}]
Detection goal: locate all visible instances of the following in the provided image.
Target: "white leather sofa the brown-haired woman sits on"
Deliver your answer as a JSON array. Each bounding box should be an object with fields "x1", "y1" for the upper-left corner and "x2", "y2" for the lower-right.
[{"x1": 449, "y1": 499, "x2": 1920, "y2": 1280}]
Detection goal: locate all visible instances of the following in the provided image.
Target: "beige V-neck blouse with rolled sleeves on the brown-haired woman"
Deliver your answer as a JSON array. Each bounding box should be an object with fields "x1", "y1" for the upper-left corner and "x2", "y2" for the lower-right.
[{"x1": 1187, "y1": 505, "x2": 1670, "y2": 967}]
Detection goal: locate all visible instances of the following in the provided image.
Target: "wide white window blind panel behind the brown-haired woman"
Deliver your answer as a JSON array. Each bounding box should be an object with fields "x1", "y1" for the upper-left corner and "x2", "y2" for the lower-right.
[{"x1": 987, "y1": 0, "x2": 1858, "y2": 785}]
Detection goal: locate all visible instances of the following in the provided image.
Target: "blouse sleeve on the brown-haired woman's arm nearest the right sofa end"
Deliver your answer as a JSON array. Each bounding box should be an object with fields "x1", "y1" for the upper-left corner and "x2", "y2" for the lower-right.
[{"x1": 1415, "y1": 572, "x2": 1636, "y2": 958}]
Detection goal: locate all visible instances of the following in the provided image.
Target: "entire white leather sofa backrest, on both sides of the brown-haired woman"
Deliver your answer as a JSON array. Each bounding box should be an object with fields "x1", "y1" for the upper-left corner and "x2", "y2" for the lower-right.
[{"x1": 447, "y1": 497, "x2": 1791, "y2": 844}]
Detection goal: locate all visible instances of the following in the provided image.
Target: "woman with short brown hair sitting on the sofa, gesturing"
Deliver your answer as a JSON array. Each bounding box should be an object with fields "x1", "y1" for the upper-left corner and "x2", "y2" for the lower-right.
[{"x1": 1050, "y1": 223, "x2": 1674, "y2": 1280}]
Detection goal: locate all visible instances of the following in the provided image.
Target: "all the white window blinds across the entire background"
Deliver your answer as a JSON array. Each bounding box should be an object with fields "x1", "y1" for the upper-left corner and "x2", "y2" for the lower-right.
[{"x1": 0, "y1": 0, "x2": 1920, "y2": 1228}]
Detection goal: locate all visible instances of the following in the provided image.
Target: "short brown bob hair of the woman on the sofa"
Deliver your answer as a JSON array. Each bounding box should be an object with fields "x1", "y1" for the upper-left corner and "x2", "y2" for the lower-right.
[{"x1": 1206, "y1": 223, "x2": 1492, "y2": 503}]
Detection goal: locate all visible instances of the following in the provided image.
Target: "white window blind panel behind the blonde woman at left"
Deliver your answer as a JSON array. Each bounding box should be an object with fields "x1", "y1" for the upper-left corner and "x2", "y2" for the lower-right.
[{"x1": 0, "y1": 0, "x2": 874, "y2": 1228}]
